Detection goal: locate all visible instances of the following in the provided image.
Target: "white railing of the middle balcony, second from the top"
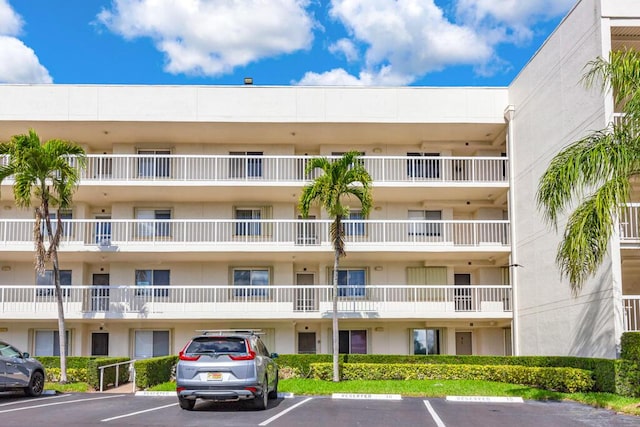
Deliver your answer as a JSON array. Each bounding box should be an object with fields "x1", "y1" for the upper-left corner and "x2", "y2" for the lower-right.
[{"x1": 0, "y1": 219, "x2": 510, "y2": 249}]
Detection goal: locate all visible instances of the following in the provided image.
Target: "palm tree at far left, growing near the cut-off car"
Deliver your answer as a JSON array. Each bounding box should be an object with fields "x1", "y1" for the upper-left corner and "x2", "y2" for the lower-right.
[{"x1": 0, "y1": 130, "x2": 85, "y2": 383}]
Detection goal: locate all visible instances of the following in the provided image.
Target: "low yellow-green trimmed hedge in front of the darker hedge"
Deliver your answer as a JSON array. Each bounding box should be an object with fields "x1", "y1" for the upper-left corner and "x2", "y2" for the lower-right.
[{"x1": 311, "y1": 363, "x2": 594, "y2": 393}]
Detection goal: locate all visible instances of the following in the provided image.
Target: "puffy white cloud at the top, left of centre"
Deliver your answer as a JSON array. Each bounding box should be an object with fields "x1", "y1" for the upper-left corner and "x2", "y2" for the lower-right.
[{"x1": 98, "y1": 0, "x2": 315, "y2": 76}]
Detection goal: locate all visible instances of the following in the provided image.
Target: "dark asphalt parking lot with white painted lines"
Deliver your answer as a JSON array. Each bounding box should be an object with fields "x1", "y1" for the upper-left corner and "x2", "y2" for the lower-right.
[{"x1": 0, "y1": 393, "x2": 640, "y2": 427}]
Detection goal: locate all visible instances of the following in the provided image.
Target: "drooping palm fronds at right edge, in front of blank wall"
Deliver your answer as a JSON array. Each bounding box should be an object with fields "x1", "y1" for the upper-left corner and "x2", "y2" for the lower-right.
[{"x1": 537, "y1": 46, "x2": 640, "y2": 295}]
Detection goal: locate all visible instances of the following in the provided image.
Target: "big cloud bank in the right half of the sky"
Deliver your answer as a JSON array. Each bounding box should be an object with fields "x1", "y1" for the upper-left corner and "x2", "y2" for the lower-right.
[{"x1": 299, "y1": 0, "x2": 575, "y2": 84}]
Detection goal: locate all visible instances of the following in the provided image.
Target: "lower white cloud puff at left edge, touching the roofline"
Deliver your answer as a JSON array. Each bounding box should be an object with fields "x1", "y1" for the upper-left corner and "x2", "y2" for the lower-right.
[{"x1": 0, "y1": 36, "x2": 53, "y2": 83}]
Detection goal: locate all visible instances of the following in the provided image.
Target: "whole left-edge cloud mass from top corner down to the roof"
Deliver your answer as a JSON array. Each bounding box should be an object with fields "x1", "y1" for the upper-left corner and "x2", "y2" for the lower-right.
[{"x1": 0, "y1": 0, "x2": 53, "y2": 83}]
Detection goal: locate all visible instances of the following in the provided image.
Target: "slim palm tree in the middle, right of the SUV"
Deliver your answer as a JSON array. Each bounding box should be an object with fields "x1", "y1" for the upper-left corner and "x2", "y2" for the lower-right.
[{"x1": 298, "y1": 151, "x2": 372, "y2": 382}]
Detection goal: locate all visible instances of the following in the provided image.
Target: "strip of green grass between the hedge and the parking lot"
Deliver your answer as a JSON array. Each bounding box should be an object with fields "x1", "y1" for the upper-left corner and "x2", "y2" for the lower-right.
[{"x1": 142, "y1": 379, "x2": 640, "y2": 415}]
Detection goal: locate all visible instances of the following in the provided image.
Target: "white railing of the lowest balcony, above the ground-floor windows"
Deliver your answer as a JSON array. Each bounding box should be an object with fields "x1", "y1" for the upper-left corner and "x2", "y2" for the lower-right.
[{"x1": 0, "y1": 285, "x2": 512, "y2": 319}]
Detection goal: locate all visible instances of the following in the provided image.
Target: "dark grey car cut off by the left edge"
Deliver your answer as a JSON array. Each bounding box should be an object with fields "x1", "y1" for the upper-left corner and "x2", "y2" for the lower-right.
[{"x1": 0, "y1": 341, "x2": 44, "y2": 396}]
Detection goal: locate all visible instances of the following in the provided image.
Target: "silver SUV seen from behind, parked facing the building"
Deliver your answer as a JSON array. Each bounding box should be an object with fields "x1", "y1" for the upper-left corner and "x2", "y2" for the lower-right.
[{"x1": 176, "y1": 330, "x2": 278, "y2": 411}]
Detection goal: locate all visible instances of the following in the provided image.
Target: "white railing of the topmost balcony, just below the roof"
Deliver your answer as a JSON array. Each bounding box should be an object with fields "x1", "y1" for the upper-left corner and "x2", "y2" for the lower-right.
[{"x1": 61, "y1": 154, "x2": 509, "y2": 184}]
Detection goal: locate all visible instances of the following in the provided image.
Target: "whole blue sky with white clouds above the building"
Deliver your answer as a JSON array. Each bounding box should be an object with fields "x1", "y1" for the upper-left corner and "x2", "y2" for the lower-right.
[{"x1": 0, "y1": 0, "x2": 576, "y2": 86}]
